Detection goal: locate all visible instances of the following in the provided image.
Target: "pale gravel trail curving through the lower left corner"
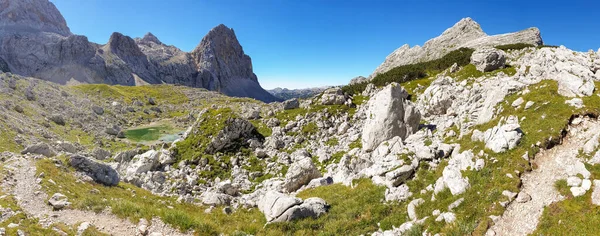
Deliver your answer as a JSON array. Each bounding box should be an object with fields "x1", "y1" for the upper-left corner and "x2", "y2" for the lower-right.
[{"x1": 3, "y1": 156, "x2": 187, "y2": 236}]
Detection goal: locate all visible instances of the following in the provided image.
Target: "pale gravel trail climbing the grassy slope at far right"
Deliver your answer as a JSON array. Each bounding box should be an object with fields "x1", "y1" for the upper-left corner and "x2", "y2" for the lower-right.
[{"x1": 486, "y1": 120, "x2": 600, "y2": 236}]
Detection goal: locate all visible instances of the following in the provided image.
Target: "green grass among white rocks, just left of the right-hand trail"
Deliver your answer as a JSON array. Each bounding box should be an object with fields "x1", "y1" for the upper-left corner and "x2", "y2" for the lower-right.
[{"x1": 407, "y1": 80, "x2": 600, "y2": 235}]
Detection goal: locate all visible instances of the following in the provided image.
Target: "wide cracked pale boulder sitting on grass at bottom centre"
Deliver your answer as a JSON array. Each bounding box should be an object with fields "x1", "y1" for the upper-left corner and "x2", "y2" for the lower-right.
[{"x1": 258, "y1": 191, "x2": 329, "y2": 222}]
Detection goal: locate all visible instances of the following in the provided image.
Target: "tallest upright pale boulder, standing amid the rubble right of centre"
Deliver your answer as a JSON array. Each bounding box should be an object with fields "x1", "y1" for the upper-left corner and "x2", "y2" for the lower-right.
[{"x1": 361, "y1": 83, "x2": 421, "y2": 151}]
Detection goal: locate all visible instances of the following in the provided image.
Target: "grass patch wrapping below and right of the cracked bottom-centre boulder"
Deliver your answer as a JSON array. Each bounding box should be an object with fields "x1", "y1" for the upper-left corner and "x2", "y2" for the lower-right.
[{"x1": 265, "y1": 179, "x2": 408, "y2": 235}]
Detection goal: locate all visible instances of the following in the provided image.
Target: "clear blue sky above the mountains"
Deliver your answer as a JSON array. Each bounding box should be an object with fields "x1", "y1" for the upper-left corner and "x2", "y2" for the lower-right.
[{"x1": 51, "y1": 0, "x2": 600, "y2": 88}]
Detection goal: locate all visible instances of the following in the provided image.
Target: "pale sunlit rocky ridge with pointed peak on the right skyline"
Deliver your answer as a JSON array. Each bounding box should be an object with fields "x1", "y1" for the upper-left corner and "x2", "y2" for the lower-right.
[{"x1": 369, "y1": 17, "x2": 543, "y2": 79}]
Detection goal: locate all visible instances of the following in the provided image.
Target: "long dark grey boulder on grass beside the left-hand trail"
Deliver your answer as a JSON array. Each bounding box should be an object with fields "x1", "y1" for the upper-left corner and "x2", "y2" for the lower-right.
[{"x1": 69, "y1": 155, "x2": 119, "y2": 186}]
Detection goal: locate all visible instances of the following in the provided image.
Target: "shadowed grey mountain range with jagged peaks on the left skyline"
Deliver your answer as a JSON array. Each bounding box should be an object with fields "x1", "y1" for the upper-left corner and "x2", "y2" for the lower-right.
[{"x1": 0, "y1": 0, "x2": 279, "y2": 102}]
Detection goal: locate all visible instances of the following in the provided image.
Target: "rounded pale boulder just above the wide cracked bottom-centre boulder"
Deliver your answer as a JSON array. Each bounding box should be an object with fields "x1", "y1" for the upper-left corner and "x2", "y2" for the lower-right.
[{"x1": 284, "y1": 157, "x2": 321, "y2": 192}]
